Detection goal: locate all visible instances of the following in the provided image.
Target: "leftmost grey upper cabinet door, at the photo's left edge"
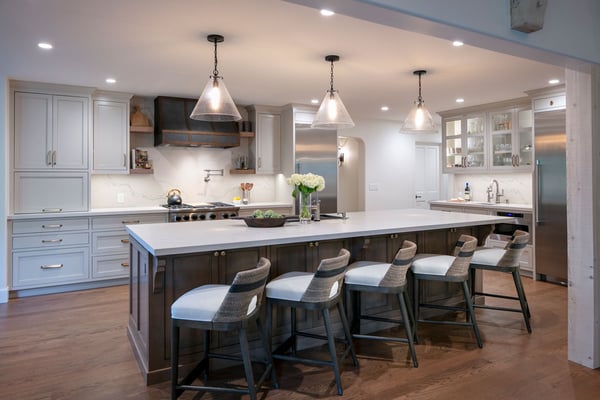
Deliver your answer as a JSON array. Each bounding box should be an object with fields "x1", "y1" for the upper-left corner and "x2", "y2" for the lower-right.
[{"x1": 14, "y1": 92, "x2": 52, "y2": 169}]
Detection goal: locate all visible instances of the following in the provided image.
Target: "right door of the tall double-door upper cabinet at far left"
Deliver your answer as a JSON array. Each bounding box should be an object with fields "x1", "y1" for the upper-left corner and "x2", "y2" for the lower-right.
[{"x1": 52, "y1": 96, "x2": 89, "y2": 169}]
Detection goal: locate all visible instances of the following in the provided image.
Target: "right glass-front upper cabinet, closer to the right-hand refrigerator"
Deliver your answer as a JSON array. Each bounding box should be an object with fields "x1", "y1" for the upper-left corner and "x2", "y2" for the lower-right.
[{"x1": 489, "y1": 108, "x2": 533, "y2": 170}]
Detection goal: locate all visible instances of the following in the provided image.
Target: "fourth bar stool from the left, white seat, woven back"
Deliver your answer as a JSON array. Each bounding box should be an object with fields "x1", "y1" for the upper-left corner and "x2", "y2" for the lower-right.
[{"x1": 412, "y1": 235, "x2": 483, "y2": 348}]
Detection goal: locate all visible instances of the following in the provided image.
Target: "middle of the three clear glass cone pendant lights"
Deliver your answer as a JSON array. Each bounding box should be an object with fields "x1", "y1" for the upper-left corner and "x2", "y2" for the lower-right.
[{"x1": 311, "y1": 55, "x2": 354, "y2": 129}]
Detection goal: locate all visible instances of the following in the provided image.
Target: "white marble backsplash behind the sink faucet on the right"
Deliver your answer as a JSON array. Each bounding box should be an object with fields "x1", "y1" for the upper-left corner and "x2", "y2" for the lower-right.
[{"x1": 448, "y1": 172, "x2": 533, "y2": 204}]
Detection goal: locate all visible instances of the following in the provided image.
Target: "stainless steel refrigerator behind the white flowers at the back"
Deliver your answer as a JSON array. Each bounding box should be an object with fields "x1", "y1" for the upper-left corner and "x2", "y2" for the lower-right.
[{"x1": 295, "y1": 124, "x2": 338, "y2": 214}]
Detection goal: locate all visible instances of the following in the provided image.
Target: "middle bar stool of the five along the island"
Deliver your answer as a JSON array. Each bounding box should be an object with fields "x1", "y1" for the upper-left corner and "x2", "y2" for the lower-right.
[{"x1": 344, "y1": 240, "x2": 419, "y2": 367}]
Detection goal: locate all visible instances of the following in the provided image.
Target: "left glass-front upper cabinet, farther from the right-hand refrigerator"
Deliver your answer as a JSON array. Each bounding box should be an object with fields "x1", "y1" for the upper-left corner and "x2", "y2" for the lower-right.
[{"x1": 442, "y1": 114, "x2": 487, "y2": 172}]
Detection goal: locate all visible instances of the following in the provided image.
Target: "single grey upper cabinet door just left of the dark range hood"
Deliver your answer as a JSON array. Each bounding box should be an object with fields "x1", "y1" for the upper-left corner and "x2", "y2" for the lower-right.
[{"x1": 93, "y1": 100, "x2": 129, "y2": 174}]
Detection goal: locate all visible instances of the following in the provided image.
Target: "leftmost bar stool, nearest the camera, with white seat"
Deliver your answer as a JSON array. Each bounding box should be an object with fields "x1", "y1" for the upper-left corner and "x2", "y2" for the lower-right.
[{"x1": 171, "y1": 258, "x2": 278, "y2": 400}]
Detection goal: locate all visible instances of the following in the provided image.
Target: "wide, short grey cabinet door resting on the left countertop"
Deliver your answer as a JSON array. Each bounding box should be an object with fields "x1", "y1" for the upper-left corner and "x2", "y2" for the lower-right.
[{"x1": 13, "y1": 172, "x2": 89, "y2": 214}]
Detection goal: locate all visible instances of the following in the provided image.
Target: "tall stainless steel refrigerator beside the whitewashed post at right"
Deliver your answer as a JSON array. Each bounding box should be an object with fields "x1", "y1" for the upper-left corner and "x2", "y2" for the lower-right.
[{"x1": 534, "y1": 109, "x2": 567, "y2": 283}]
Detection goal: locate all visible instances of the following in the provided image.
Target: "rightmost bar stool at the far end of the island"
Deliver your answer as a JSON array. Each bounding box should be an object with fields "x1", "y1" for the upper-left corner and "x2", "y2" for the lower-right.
[{"x1": 471, "y1": 230, "x2": 531, "y2": 333}]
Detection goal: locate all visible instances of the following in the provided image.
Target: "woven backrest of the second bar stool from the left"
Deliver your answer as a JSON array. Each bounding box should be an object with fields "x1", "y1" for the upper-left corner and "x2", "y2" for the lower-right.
[{"x1": 302, "y1": 249, "x2": 350, "y2": 303}]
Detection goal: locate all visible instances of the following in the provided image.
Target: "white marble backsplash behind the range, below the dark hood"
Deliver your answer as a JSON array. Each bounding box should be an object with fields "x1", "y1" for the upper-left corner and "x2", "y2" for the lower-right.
[{"x1": 91, "y1": 147, "x2": 293, "y2": 208}]
